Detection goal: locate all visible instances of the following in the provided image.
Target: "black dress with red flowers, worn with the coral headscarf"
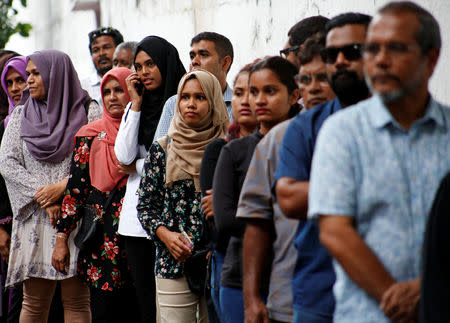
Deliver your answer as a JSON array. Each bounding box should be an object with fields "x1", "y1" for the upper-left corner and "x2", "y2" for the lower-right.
[{"x1": 57, "y1": 137, "x2": 130, "y2": 291}]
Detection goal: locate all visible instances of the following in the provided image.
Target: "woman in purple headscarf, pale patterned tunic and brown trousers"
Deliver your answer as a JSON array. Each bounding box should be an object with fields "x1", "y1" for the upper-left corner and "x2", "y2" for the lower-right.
[{"x1": 0, "y1": 50, "x2": 101, "y2": 322}]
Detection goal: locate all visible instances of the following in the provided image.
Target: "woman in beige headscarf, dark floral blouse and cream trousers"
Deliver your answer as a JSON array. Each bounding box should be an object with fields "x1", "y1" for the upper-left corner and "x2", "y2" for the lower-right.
[{"x1": 137, "y1": 70, "x2": 228, "y2": 323}]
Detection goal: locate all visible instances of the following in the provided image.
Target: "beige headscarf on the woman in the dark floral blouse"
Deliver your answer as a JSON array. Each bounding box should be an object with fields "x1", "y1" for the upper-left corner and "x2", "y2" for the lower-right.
[{"x1": 158, "y1": 70, "x2": 229, "y2": 192}]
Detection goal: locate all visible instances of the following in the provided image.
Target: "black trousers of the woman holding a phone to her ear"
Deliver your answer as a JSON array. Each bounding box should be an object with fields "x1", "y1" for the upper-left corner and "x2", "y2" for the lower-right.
[{"x1": 122, "y1": 236, "x2": 156, "y2": 323}]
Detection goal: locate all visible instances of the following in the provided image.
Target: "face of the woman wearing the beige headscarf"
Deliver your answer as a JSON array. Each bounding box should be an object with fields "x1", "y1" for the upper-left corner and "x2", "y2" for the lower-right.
[{"x1": 180, "y1": 79, "x2": 209, "y2": 127}]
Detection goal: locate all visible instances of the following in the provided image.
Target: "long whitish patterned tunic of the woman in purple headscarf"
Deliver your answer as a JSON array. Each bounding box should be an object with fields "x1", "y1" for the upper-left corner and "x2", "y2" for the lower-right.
[{"x1": 0, "y1": 102, "x2": 101, "y2": 287}]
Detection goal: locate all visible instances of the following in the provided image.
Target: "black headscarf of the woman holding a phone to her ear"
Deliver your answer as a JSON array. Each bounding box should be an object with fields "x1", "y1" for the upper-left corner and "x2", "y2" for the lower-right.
[{"x1": 134, "y1": 36, "x2": 186, "y2": 150}]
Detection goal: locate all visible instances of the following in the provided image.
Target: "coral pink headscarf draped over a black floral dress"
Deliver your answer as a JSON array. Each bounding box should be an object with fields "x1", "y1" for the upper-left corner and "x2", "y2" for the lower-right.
[{"x1": 75, "y1": 67, "x2": 132, "y2": 192}]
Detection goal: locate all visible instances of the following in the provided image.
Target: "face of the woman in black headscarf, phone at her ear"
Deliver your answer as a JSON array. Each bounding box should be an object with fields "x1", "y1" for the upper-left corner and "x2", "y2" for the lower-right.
[{"x1": 134, "y1": 50, "x2": 162, "y2": 91}]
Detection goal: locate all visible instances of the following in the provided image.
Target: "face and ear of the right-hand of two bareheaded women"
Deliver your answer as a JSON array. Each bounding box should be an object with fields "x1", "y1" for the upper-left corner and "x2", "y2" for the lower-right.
[{"x1": 249, "y1": 68, "x2": 298, "y2": 124}]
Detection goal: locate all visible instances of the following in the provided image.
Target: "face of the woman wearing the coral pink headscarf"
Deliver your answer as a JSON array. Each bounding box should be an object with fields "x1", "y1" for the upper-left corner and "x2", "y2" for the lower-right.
[{"x1": 102, "y1": 77, "x2": 128, "y2": 117}]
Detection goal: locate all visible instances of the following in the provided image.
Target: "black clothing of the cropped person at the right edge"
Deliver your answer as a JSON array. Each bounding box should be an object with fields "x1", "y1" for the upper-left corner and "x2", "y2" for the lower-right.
[{"x1": 419, "y1": 173, "x2": 450, "y2": 323}]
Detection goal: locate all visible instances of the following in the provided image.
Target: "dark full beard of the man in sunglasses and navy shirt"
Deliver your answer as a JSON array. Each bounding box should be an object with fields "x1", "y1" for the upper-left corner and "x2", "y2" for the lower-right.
[{"x1": 330, "y1": 69, "x2": 369, "y2": 106}]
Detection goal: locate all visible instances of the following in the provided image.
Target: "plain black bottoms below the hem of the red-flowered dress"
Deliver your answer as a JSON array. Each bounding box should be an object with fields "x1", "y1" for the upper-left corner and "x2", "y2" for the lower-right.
[{"x1": 89, "y1": 287, "x2": 139, "y2": 323}]
